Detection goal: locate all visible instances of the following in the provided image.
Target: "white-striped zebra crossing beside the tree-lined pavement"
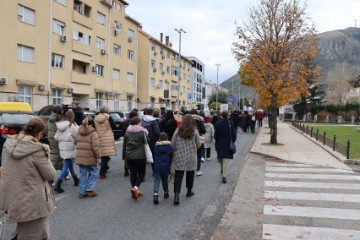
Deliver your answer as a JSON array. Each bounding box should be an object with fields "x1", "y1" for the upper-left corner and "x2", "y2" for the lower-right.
[{"x1": 262, "y1": 162, "x2": 360, "y2": 240}]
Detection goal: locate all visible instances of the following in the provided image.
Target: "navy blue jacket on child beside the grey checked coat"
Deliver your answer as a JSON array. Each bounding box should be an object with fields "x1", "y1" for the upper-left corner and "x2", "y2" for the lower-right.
[{"x1": 154, "y1": 141, "x2": 172, "y2": 174}]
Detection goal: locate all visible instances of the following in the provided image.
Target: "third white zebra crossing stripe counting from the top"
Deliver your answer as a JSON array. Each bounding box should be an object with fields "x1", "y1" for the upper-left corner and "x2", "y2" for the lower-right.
[{"x1": 265, "y1": 173, "x2": 360, "y2": 181}]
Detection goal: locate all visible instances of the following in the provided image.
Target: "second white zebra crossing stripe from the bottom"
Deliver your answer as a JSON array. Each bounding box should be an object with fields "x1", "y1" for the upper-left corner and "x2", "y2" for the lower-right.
[{"x1": 264, "y1": 205, "x2": 360, "y2": 221}]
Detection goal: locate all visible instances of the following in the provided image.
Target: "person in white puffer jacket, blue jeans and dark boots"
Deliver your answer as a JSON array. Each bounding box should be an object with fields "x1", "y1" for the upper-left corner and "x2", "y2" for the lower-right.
[{"x1": 54, "y1": 110, "x2": 79, "y2": 193}]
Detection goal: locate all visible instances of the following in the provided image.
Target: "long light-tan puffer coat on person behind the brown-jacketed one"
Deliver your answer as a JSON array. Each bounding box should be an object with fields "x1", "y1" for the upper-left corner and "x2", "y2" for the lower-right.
[{"x1": 94, "y1": 113, "x2": 116, "y2": 157}]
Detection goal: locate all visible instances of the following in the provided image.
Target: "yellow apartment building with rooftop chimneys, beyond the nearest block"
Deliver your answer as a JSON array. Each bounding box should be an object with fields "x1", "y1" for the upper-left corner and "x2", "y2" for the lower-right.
[{"x1": 137, "y1": 30, "x2": 192, "y2": 109}]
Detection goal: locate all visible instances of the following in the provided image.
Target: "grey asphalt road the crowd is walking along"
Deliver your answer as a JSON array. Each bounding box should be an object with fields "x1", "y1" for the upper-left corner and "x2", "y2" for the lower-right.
[{"x1": 2, "y1": 133, "x2": 256, "y2": 240}]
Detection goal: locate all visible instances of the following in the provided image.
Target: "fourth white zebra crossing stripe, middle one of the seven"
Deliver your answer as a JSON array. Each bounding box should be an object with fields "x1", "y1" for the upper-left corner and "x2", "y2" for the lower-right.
[{"x1": 265, "y1": 181, "x2": 360, "y2": 190}]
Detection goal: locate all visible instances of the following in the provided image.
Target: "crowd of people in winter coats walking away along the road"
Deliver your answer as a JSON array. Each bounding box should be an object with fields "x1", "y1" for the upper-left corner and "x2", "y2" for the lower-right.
[{"x1": 0, "y1": 103, "x2": 264, "y2": 239}]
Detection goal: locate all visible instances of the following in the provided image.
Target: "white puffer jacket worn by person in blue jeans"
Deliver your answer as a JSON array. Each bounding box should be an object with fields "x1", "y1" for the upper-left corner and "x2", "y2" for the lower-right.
[{"x1": 54, "y1": 121, "x2": 78, "y2": 159}]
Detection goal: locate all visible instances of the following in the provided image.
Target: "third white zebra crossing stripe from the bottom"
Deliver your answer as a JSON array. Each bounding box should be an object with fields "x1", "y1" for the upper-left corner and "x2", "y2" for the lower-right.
[{"x1": 264, "y1": 191, "x2": 360, "y2": 203}]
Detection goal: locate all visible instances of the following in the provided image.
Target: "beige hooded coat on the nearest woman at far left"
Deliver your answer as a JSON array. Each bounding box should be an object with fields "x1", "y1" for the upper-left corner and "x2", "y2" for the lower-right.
[{"x1": 0, "y1": 134, "x2": 56, "y2": 223}]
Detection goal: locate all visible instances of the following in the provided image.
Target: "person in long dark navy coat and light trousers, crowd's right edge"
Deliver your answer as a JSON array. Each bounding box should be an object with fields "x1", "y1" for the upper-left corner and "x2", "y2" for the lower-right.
[{"x1": 214, "y1": 111, "x2": 237, "y2": 183}]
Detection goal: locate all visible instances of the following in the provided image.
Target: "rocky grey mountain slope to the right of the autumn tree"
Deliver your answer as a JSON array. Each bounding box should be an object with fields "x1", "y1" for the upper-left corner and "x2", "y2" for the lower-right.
[{"x1": 317, "y1": 27, "x2": 360, "y2": 85}]
